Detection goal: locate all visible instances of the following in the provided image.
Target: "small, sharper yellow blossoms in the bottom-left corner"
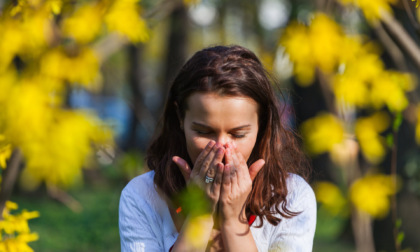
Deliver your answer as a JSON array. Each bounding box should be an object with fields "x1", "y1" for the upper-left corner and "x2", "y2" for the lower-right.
[{"x1": 0, "y1": 201, "x2": 39, "y2": 252}]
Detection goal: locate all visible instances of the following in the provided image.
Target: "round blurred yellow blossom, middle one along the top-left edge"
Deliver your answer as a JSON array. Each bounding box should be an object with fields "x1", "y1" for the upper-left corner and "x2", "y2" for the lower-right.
[{"x1": 62, "y1": 4, "x2": 103, "y2": 43}]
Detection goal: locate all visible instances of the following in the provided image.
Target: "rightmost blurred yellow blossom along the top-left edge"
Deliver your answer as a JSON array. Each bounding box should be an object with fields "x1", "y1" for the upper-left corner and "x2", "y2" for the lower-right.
[{"x1": 105, "y1": 0, "x2": 149, "y2": 43}]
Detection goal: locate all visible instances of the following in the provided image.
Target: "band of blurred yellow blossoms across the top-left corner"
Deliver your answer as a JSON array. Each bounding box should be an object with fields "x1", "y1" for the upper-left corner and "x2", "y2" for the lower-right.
[{"x1": 0, "y1": 0, "x2": 149, "y2": 72}]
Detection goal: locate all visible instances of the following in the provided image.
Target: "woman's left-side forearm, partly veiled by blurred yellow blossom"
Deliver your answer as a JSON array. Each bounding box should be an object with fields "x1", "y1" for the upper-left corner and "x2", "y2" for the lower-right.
[{"x1": 172, "y1": 214, "x2": 214, "y2": 252}]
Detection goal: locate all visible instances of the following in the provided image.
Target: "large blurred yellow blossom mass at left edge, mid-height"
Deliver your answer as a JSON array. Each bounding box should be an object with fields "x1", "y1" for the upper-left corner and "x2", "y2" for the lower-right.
[{"x1": 0, "y1": 75, "x2": 111, "y2": 189}]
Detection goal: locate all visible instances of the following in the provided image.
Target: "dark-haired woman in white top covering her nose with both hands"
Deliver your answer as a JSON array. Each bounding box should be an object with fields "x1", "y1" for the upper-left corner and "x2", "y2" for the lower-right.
[{"x1": 119, "y1": 46, "x2": 316, "y2": 251}]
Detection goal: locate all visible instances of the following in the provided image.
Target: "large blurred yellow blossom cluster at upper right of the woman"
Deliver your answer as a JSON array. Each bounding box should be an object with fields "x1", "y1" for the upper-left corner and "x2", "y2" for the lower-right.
[{"x1": 280, "y1": 14, "x2": 415, "y2": 112}]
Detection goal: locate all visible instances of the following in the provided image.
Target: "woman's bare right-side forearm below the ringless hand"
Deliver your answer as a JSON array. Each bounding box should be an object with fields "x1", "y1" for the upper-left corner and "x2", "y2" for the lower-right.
[{"x1": 221, "y1": 220, "x2": 258, "y2": 251}]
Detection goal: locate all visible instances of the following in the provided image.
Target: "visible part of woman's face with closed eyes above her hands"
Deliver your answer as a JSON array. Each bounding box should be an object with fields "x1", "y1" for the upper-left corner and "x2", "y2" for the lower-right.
[{"x1": 183, "y1": 93, "x2": 258, "y2": 164}]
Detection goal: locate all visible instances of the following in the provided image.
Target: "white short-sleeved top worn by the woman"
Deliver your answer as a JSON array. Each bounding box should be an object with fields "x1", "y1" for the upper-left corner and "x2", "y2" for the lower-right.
[{"x1": 119, "y1": 171, "x2": 316, "y2": 252}]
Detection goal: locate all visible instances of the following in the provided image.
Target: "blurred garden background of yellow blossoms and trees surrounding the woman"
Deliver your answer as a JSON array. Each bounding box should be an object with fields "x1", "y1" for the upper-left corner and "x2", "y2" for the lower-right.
[{"x1": 0, "y1": 0, "x2": 420, "y2": 252}]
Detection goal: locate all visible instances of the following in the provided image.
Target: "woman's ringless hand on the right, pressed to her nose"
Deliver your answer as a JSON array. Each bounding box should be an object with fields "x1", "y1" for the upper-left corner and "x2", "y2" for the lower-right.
[{"x1": 219, "y1": 144, "x2": 265, "y2": 225}]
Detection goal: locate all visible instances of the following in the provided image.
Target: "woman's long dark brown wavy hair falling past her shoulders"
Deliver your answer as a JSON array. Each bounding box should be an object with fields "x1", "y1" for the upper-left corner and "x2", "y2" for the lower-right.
[{"x1": 147, "y1": 46, "x2": 309, "y2": 225}]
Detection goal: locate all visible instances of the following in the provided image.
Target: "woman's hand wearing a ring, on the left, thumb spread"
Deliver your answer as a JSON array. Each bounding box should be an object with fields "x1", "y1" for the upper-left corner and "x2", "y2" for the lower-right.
[{"x1": 172, "y1": 140, "x2": 225, "y2": 214}]
